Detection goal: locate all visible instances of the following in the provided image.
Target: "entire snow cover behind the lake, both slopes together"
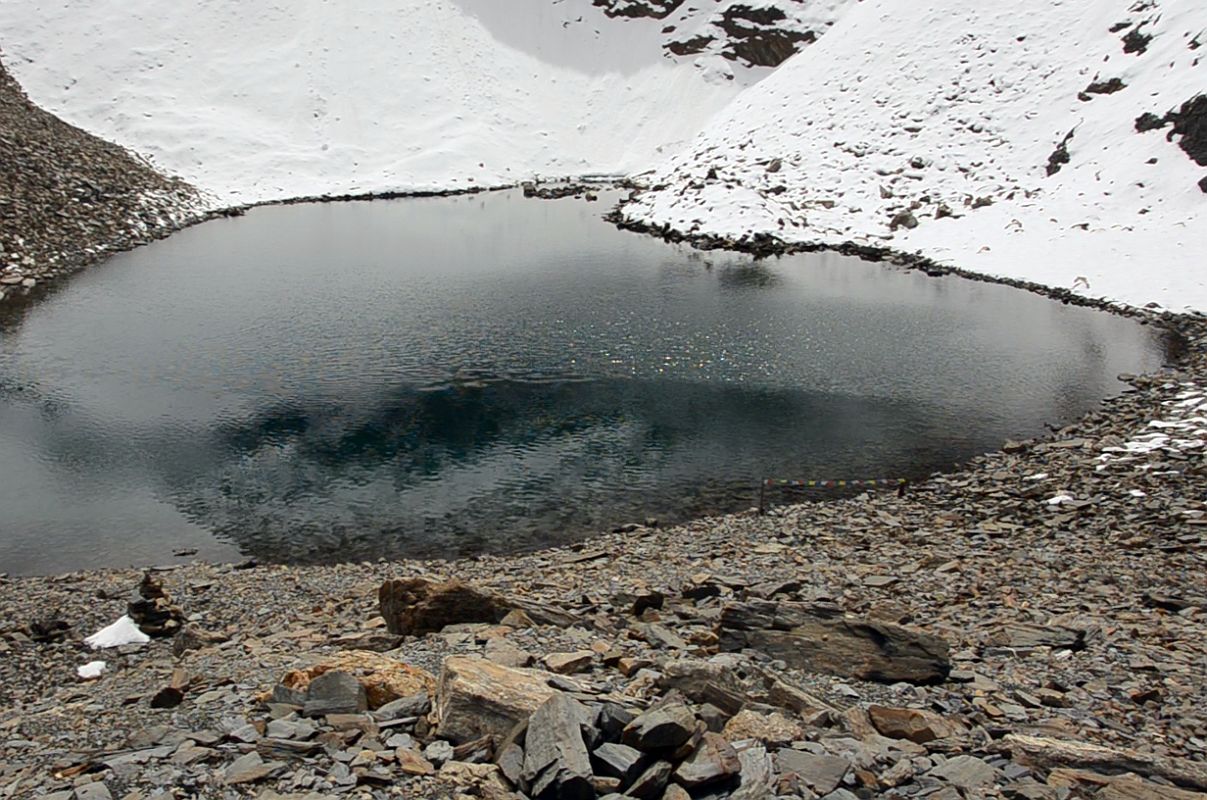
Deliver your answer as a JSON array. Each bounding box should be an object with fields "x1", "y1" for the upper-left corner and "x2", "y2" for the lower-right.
[{"x1": 0, "y1": 0, "x2": 1207, "y2": 309}]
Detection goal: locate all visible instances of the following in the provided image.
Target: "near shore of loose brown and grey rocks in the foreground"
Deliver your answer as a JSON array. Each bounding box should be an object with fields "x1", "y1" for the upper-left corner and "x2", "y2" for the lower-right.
[{"x1": 0, "y1": 333, "x2": 1207, "y2": 800}]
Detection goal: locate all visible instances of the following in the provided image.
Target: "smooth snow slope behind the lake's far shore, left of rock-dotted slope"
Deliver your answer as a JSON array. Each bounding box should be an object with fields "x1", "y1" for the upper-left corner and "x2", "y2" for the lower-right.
[{"x1": 0, "y1": 0, "x2": 851, "y2": 203}]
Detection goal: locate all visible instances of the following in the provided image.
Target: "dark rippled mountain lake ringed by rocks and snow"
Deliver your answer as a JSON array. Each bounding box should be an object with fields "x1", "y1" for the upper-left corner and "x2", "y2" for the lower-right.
[{"x1": 0, "y1": 193, "x2": 1162, "y2": 573}]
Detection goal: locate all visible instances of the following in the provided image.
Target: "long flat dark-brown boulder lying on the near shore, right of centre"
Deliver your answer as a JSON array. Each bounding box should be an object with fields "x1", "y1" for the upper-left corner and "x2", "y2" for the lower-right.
[{"x1": 721, "y1": 601, "x2": 951, "y2": 683}]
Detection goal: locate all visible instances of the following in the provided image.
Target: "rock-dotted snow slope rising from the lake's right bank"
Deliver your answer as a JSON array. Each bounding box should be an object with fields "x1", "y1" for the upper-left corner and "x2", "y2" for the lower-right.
[{"x1": 626, "y1": 0, "x2": 1207, "y2": 309}]
